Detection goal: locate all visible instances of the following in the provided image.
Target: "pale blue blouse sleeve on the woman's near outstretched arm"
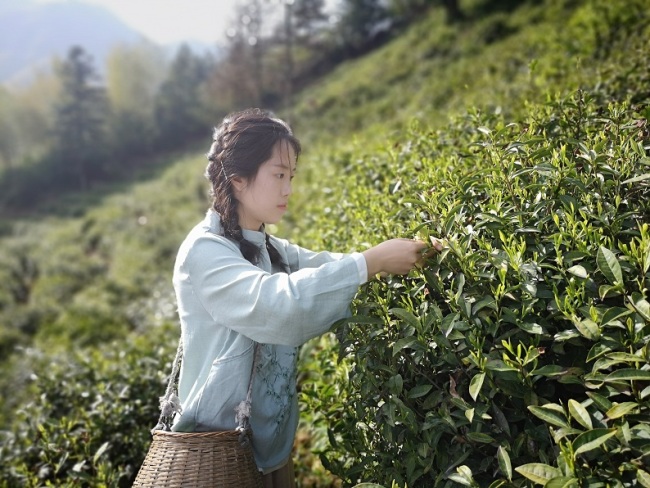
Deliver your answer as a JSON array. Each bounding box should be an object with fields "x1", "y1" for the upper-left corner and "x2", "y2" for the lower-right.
[{"x1": 175, "y1": 236, "x2": 361, "y2": 346}]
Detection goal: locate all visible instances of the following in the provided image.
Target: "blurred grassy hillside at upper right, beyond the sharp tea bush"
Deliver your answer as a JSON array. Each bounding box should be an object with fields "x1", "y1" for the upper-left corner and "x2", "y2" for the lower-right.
[{"x1": 288, "y1": 0, "x2": 650, "y2": 239}]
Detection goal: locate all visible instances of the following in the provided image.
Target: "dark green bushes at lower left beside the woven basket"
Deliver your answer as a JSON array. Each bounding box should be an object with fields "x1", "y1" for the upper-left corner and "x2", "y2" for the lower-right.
[{"x1": 0, "y1": 327, "x2": 178, "y2": 487}]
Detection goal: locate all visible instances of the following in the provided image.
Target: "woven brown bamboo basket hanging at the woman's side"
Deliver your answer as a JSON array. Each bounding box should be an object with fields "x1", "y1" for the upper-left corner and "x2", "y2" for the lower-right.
[{"x1": 133, "y1": 430, "x2": 262, "y2": 488}]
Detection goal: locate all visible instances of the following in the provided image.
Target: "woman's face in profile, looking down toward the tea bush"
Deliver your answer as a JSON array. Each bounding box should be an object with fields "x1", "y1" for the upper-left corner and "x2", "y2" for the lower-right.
[{"x1": 232, "y1": 141, "x2": 296, "y2": 230}]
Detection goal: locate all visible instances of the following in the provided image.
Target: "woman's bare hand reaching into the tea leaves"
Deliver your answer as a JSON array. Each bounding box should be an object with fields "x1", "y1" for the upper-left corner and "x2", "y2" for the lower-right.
[{"x1": 356, "y1": 239, "x2": 442, "y2": 279}]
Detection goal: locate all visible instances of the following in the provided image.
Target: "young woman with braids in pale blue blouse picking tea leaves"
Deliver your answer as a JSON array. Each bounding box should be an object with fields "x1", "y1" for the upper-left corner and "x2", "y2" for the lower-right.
[{"x1": 173, "y1": 109, "x2": 438, "y2": 487}]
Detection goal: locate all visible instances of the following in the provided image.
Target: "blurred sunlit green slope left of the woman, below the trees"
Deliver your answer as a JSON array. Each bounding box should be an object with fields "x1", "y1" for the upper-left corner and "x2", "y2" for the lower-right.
[{"x1": 0, "y1": 156, "x2": 207, "y2": 426}]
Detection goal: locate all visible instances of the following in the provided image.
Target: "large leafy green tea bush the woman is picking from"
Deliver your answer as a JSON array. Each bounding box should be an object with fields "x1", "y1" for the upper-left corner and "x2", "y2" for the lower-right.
[{"x1": 305, "y1": 92, "x2": 650, "y2": 487}]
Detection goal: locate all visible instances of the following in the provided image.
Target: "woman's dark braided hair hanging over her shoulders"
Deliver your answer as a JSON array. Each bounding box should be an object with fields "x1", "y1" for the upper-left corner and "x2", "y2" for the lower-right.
[{"x1": 205, "y1": 109, "x2": 300, "y2": 269}]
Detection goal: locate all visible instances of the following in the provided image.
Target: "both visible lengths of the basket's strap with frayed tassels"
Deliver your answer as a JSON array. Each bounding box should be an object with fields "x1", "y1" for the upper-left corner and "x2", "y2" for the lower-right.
[{"x1": 151, "y1": 337, "x2": 259, "y2": 436}]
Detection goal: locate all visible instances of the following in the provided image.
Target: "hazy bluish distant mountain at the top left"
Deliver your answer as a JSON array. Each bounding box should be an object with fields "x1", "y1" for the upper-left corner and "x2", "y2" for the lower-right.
[{"x1": 0, "y1": 0, "x2": 143, "y2": 83}]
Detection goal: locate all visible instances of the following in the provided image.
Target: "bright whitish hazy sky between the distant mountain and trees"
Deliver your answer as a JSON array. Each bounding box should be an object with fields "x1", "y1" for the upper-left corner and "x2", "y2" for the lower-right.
[{"x1": 38, "y1": 0, "x2": 238, "y2": 44}]
